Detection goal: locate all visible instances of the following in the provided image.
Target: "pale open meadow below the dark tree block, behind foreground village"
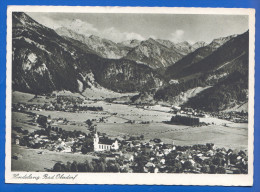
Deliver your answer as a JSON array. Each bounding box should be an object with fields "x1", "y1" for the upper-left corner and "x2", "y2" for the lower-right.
[{"x1": 98, "y1": 123, "x2": 248, "y2": 150}]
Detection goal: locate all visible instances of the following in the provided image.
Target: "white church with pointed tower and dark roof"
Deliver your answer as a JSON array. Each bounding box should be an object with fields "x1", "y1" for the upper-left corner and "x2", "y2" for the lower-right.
[{"x1": 93, "y1": 132, "x2": 119, "y2": 151}]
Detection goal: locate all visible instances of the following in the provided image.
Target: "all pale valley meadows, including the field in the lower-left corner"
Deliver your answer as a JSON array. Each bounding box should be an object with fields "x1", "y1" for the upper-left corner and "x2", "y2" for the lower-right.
[{"x1": 12, "y1": 93, "x2": 248, "y2": 171}]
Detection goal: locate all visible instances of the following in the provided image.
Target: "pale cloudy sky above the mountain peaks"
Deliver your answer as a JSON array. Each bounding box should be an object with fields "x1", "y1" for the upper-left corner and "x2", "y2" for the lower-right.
[{"x1": 27, "y1": 12, "x2": 249, "y2": 43}]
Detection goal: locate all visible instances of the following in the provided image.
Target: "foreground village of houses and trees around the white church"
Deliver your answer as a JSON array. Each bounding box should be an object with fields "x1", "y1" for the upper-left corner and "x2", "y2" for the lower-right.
[{"x1": 12, "y1": 108, "x2": 248, "y2": 174}]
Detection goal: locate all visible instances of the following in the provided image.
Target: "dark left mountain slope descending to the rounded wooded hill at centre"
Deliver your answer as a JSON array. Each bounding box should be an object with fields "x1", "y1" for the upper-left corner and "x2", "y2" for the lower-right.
[{"x1": 12, "y1": 12, "x2": 164, "y2": 94}]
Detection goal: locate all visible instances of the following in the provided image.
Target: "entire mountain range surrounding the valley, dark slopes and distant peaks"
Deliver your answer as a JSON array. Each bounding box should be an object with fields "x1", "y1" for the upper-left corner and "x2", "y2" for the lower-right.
[{"x1": 12, "y1": 12, "x2": 249, "y2": 111}]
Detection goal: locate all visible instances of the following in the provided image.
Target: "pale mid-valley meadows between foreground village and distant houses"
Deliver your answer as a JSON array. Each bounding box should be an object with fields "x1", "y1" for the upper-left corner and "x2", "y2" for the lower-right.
[{"x1": 13, "y1": 102, "x2": 248, "y2": 149}]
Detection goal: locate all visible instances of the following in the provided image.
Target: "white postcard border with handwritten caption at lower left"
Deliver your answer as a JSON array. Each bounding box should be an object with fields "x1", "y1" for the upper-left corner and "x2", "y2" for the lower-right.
[{"x1": 5, "y1": 6, "x2": 255, "y2": 186}]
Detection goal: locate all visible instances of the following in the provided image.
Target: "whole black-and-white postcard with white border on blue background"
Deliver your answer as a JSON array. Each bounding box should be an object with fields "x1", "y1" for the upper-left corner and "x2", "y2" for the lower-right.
[{"x1": 6, "y1": 6, "x2": 255, "y2": 185}]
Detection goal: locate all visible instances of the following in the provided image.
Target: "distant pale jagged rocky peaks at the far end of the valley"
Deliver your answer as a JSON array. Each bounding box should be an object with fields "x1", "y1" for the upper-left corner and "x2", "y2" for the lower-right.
[{"x1": 56, "y1": 27, "x2": 209, "y2": 69}]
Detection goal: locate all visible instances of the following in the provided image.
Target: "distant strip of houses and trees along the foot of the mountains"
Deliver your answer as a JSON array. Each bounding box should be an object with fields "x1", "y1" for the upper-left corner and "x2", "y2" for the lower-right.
[{"x1": 12, "y1": 94, "x2": 248, "y2": 126}]
